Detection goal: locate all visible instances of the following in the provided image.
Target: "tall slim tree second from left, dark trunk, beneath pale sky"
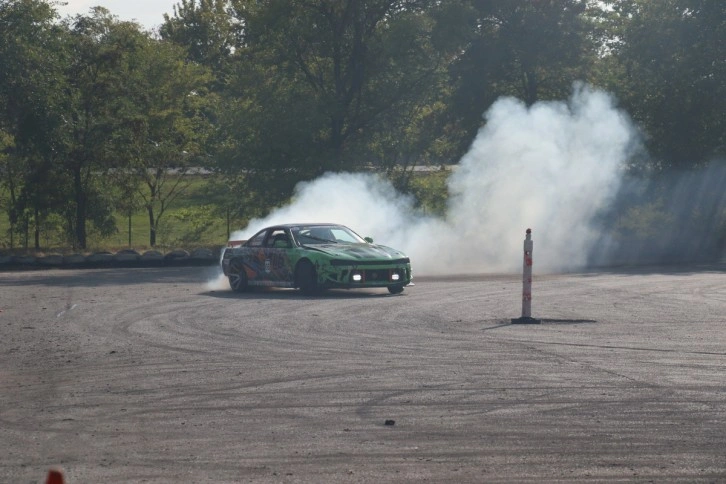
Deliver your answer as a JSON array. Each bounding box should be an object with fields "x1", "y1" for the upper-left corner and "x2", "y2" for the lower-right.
[{"x1": 53, "y1": 7, "x2": 152, "y2": 248}]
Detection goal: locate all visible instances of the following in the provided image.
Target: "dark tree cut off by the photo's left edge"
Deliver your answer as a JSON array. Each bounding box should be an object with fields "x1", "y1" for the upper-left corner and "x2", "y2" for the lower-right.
[{"x1": 0, "y1": 0, "x2": 66, "y2": 248}]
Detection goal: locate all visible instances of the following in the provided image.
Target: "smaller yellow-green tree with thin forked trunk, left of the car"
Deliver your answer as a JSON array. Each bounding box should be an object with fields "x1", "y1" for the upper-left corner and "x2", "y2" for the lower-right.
[{"x1": 112, "y1": 36, "x2": 214, "y2": 247}]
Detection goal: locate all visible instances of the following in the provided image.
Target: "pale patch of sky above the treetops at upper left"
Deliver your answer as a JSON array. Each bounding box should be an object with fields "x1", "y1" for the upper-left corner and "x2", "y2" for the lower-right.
[{"x1": 56, "y1": 0, "x2": 180, "y2": 30}]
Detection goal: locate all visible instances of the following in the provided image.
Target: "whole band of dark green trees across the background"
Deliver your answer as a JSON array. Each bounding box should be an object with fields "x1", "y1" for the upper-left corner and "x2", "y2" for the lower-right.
[{"x1": 0, "y1": 0, "x2": 726, "y2": 248}]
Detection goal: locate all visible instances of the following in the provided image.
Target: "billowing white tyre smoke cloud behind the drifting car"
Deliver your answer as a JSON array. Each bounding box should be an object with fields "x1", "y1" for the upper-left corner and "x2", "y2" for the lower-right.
[{"x1": 233, "y1": 85, "x2": 635, "y2": 275}]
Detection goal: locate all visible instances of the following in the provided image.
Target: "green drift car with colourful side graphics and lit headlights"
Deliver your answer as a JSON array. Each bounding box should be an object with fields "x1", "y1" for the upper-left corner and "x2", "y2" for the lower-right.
[{"x1": 221, "y1": 224, "x2": 411, "y2": 294}]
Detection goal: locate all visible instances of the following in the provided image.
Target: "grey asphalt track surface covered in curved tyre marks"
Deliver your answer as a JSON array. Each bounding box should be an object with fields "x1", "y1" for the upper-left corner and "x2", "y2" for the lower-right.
[{"x1": 0, "y1": 264, "x2": 726, "y2": 484}]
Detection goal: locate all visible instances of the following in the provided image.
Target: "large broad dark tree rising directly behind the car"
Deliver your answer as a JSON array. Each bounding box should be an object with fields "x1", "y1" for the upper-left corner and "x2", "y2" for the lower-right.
[{"x1": 216, "y1": 0, "x2": 450, "y2": 203}]
